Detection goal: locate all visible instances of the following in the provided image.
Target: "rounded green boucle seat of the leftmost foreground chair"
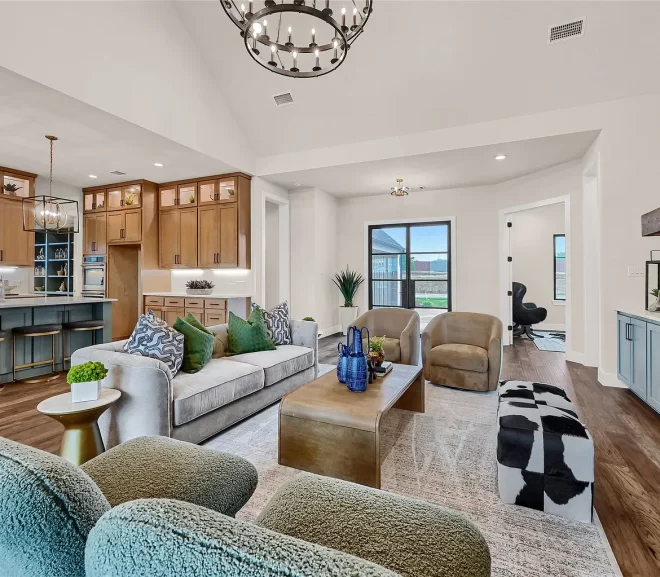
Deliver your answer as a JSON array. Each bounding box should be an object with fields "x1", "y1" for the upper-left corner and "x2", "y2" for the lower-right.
[{"x1": 80, "y1": 437, "x2": 257, "y2": 517}]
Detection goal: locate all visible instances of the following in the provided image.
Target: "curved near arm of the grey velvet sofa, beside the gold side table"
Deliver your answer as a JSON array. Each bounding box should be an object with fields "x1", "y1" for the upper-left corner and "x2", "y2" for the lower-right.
[{"x1": 71, "y1": 343, "x2": 172, "y2": 448}]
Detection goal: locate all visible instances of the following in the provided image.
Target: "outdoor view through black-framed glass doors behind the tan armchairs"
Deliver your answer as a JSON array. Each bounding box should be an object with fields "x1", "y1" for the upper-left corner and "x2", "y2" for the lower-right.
[{"x1": 369, "y1": 222, "x2": 451, "y2": 319}]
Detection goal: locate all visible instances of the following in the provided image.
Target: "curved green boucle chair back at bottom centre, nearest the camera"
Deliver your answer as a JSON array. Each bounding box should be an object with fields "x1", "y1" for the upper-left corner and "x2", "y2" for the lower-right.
[{"x1": 85, "y1": 499, "x2": 397, "y2": 577}]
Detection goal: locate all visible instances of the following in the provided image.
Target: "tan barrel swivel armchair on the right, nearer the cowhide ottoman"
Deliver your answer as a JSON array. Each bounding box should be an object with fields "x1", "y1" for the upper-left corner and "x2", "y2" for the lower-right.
[{"x1": 422, "y1": 313, "x2": 502, "y2": 391}]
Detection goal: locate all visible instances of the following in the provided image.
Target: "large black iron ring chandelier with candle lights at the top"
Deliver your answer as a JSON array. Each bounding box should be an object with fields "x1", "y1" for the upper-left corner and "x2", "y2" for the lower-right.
[{"x1": 220, "y1": 0, "x2": 373, "y2": 78}]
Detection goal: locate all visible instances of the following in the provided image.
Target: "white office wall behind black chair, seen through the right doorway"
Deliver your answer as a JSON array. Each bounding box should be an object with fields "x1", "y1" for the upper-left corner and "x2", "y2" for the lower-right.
[{"x1": 511, "y1": 204, "x2": 566, "y2": 330}]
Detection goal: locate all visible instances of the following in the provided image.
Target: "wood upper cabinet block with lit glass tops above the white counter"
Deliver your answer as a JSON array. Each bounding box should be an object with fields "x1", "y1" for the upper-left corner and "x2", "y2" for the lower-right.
[{"x1": 159, "y1": 174, "x2": 250, "y2": 268}]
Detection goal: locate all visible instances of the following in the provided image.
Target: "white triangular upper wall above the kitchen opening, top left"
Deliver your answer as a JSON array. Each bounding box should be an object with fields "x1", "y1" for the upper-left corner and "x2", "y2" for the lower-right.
[{"x1": 0, "y1": 1, "x2": 255, "y2": 173}]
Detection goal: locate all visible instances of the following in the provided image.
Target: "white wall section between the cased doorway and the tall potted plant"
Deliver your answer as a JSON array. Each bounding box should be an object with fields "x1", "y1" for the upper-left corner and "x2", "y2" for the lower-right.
[{"x1": 289, "y1": 189, "x2": 341, "y2": 334}]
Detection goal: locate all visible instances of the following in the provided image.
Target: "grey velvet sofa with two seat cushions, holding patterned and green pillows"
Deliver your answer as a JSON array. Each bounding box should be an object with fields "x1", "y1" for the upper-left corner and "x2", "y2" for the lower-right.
[{"x1": 71, "y1": 320, "x2": 318, "y2": 448}]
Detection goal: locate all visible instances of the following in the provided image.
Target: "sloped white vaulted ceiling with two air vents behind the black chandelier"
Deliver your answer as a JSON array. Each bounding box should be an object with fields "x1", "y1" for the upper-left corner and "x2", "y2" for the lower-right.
[{"x1": 177, "y1": 0, "x2": 660, "y2": 156}]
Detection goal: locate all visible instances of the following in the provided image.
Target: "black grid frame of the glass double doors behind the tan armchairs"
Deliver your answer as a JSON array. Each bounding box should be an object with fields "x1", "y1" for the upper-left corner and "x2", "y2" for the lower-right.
[{"x1": 367, "y1": 220, "x2": 453, "y2": 312}]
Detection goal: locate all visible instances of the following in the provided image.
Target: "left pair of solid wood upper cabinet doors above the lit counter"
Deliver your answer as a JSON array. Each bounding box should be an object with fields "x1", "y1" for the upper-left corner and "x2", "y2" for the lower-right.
[{"x1": 159, "y1": 207, "x2": 197, "y2": 268}]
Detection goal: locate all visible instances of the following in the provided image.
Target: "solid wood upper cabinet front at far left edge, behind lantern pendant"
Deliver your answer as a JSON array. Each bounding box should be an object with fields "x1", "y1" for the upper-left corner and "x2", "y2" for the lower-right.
[{"x1": 0, "y1": 195, "x2": 34, "y2": 267}]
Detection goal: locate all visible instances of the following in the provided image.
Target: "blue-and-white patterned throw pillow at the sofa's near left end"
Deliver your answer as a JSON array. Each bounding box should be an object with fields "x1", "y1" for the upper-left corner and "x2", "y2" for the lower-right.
[{"x1": 124, "y1": 311, "x2": 184, "y2": 377}]
